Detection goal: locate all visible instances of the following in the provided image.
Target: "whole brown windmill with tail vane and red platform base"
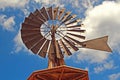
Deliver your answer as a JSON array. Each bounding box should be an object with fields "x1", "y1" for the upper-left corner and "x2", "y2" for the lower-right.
[{"x1": 21, "y1": 7, "x2": 111, "y2": 80}]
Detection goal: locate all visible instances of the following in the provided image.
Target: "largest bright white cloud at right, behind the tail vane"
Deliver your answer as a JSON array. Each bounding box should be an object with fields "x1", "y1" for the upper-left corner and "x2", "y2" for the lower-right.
[{"x1": 77, "y1": 1, "x2": 120, "y2": 62}]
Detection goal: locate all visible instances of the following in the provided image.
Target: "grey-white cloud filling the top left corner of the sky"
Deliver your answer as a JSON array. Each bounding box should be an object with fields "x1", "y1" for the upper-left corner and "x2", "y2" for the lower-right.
[{"x1": 0, "y1": 0, "x2": 29, "y2": 9}]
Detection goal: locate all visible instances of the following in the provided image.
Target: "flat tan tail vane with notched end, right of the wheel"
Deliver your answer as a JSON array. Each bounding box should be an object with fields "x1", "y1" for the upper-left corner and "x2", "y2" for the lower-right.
[{"x1": 83, "y1": 36, "x2": 112, "y2": 52}]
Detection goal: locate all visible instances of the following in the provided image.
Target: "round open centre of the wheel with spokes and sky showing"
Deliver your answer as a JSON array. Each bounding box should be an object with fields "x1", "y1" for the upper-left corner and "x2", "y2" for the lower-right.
[{"x1": 40, "y1": 20, "x2": 68, "y2": 40}]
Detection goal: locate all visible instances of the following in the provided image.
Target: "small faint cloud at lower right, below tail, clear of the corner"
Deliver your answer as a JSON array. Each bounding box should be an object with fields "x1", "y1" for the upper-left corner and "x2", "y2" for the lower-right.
[{"x1": 94, "y1": 61, "x2": 116, "y2": 73}]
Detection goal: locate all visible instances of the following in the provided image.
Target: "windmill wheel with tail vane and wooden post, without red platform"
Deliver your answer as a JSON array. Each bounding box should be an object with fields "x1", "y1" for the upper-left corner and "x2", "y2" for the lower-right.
[{"x1": 21, "y1": 7, "x2": 111, "y2": 67}]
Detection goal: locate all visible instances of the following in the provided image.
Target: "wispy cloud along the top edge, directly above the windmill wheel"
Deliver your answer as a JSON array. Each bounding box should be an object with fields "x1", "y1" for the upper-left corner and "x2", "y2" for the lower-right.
[{"x1": 34, "y1": 0, "x2": 98, "y2": 11}]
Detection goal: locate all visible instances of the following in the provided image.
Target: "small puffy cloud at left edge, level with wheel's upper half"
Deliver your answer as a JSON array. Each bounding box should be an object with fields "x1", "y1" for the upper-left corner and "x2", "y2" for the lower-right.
[{"x1": 0, "y1": 15, "x2": 15, "y2": 31}]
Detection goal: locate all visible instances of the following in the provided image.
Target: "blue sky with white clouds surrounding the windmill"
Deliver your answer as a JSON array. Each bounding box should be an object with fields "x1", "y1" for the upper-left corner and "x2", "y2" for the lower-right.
[{"x1": 0, "y1": 0, "x2": 120, "y2": 80}]
